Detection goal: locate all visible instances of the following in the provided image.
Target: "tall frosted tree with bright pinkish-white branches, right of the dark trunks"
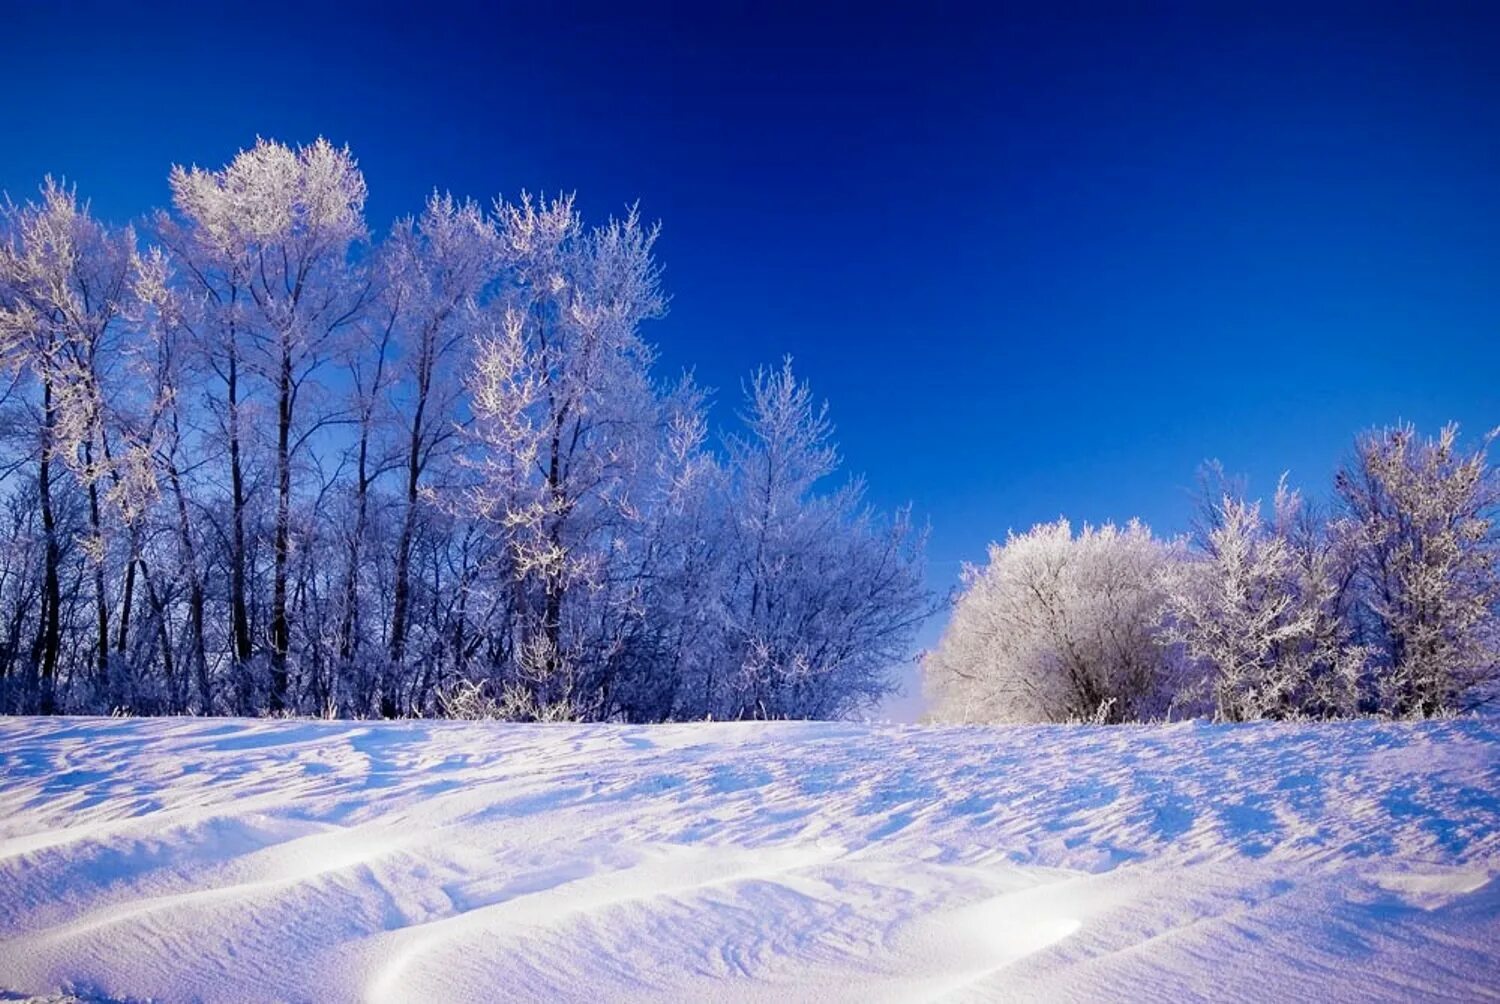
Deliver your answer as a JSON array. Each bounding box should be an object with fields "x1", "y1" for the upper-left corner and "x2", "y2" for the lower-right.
[{"x1": 465, "y1": 197, "x2": 666, "y2": 714}]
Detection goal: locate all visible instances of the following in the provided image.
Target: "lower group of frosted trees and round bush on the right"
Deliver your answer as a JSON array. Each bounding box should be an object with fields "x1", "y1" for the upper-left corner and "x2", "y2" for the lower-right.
[{"x1": 924, "y1": 426, "x2": 1500, "y2": 722}]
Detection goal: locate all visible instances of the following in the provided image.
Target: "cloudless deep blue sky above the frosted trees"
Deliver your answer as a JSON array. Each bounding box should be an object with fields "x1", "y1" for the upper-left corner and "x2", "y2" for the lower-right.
[{"x1": 0, "y1": 3, "x2": 1500, "y2": 717}]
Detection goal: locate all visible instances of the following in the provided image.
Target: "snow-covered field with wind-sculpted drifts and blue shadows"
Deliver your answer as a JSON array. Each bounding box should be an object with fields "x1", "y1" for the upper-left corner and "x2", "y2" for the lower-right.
[{"x1": 0, "y1": 719, "x2": 1500, "y2": 1002}]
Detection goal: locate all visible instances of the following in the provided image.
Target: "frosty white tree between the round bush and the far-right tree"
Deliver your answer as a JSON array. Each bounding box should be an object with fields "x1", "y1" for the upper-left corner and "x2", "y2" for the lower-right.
[{"x1": 1166, "y1": 482, "x2": 1365, "y2": 722}]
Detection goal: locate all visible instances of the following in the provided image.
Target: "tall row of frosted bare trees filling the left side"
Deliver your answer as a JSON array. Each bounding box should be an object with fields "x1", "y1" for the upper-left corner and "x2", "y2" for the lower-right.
[{"x1": 0, "y1": 141, "x2": 930, "y2": 720}]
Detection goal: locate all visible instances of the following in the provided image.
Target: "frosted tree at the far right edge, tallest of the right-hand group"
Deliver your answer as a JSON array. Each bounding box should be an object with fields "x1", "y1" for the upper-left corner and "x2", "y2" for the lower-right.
[{"x1": 1337, "y1": 425, "x2": 1500, "y2": 716}]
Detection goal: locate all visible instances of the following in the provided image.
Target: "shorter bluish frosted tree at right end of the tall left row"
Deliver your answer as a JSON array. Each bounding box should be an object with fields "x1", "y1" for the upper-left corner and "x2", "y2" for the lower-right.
[{"x1": 704, "y1": 360, "x2": 932, "y2": 717}]
